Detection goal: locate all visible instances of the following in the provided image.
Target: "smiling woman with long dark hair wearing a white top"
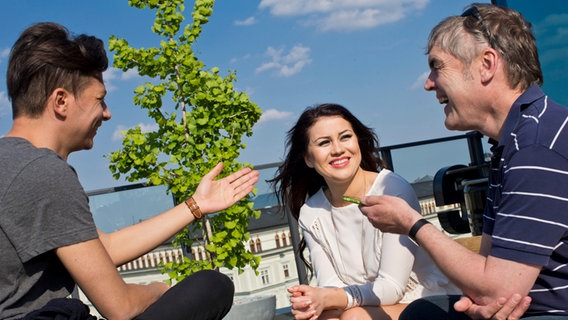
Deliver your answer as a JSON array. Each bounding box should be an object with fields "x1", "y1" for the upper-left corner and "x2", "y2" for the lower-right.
[{"x1": 269, "y1": 104, "x2": 459, "y2": 319}]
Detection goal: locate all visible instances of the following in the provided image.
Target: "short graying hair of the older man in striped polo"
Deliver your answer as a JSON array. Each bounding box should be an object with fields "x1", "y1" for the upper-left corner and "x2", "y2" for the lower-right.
[{"x1": 427, "y1": 3, "x2": 543, "y2": 91}]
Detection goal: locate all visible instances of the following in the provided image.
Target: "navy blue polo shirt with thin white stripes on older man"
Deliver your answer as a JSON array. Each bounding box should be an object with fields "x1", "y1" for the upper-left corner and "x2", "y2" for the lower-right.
[{"x1": 483, "y1": 85, "x2": 568, "y2": 315}]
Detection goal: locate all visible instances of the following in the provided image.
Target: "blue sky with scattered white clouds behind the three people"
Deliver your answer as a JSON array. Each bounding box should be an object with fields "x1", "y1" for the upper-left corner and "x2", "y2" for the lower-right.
[{"x1": 0, "y1": 0, "x2": 564, "y2": 190}]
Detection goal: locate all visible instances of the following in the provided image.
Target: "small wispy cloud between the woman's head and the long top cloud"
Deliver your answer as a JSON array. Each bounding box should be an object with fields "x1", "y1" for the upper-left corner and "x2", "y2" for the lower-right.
[{"x1": 256, "y1": 45, "x2": 312, "y2": 77}]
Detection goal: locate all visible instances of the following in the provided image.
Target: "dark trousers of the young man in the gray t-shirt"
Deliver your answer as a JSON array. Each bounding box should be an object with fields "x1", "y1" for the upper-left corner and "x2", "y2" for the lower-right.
[{"x1": 24, "y1": 270, "x2": 235, "y2": 320}]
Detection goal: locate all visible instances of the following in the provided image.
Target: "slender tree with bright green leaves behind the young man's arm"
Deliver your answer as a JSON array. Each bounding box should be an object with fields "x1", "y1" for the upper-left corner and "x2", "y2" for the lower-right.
[{"x1": 109, "y1": 0, "x2": 261, "y2": 280}]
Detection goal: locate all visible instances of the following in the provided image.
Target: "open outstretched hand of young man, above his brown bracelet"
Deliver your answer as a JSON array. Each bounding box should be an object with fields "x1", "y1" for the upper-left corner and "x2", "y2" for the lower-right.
[{"x1": 193, "y1": 162, "x2": 258, "y2": 214}]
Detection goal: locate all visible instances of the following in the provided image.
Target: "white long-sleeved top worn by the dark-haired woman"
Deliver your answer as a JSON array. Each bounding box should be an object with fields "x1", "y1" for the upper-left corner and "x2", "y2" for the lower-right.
[{"x1": 298, "y1": 169, "x2": 461, "y2": 306}]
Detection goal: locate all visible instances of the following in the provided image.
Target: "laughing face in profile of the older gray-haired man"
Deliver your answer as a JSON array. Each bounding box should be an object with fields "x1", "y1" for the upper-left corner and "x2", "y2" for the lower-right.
[{"x1": 424, "y1": 46, "x2": 484, "y2": 130}]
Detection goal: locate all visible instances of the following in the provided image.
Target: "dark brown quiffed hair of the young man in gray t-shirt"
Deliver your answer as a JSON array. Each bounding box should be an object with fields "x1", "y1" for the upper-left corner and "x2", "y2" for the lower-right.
[{"x1": 6, "y1": 22, "x2": 108, "y2": 118}]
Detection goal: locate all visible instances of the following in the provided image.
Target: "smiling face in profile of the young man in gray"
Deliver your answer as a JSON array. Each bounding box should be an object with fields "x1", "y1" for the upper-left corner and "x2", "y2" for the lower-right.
[{"x1": 68, "y1": 78, "x2": 111, "y2": 152}]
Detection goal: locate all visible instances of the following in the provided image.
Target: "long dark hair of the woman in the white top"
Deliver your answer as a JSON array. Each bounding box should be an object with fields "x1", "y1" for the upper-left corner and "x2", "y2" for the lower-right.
[{"x1": 267, "y1": 103, "x2": 385, "y2": 271}]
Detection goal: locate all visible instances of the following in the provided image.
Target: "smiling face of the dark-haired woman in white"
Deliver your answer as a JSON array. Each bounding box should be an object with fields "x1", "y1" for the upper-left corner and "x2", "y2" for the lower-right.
[{"x1": 304, "y1": 116, "x2": 361, "y2": 185}]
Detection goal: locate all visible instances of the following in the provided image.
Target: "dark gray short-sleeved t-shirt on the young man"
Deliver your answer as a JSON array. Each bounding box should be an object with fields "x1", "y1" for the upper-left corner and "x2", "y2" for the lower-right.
[{"x1": 0, "y1": 137, "x2": 98, "y2": 319}]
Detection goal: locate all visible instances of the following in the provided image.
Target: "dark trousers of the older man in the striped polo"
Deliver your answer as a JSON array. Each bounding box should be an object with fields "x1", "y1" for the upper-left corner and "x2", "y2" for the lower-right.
[{"x1": 398, "y1": 295, "x2": 568, "y2": 320}]
